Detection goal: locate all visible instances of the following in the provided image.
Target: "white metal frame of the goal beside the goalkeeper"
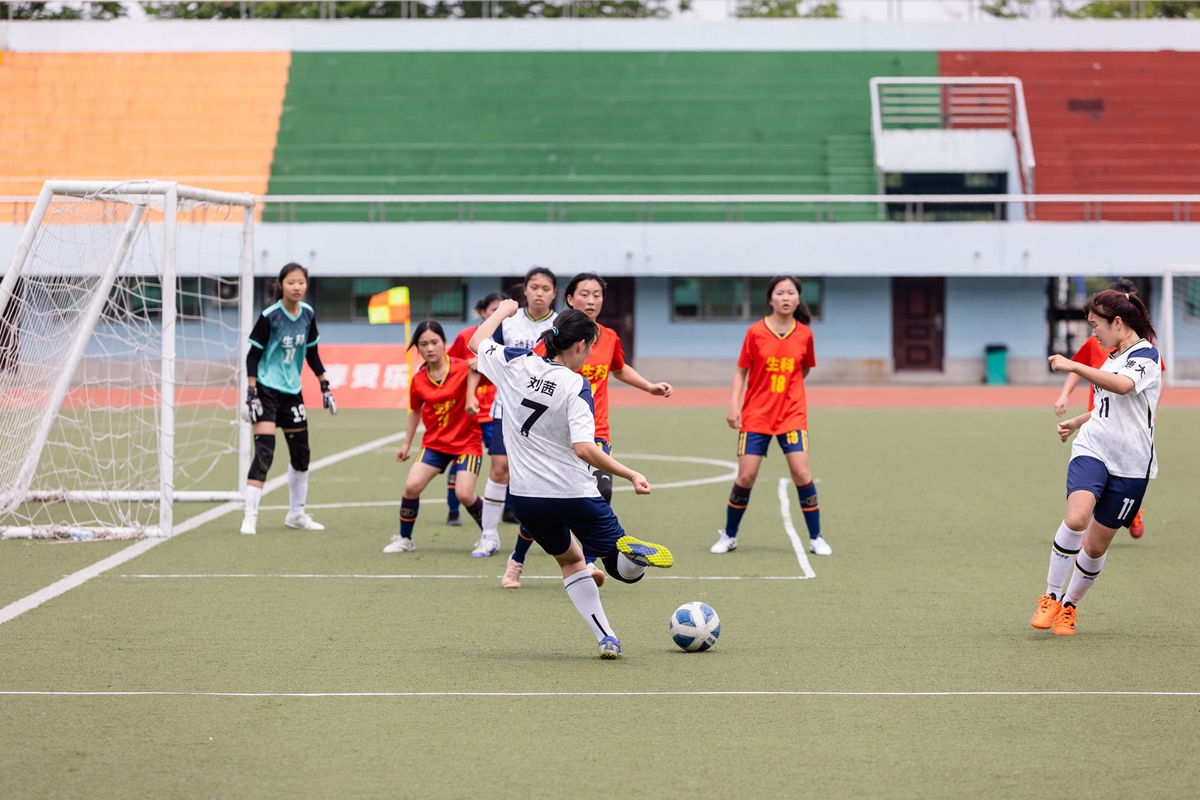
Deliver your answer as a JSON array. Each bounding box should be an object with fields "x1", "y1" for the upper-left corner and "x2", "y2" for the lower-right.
[{"x1": 0, "y1": 180, "x2": 257, "y2": 539}]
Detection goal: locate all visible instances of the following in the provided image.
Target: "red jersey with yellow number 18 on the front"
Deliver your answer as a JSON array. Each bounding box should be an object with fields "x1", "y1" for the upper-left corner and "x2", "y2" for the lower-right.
[{"x1": 738, "y1": 319, "x2": 817, "y2": 435}]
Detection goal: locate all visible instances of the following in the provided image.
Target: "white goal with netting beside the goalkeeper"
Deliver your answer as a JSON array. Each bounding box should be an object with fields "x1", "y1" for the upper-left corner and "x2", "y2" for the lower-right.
[{"x1": 0, "y1": 181, "x2": 254, "y2": 540}]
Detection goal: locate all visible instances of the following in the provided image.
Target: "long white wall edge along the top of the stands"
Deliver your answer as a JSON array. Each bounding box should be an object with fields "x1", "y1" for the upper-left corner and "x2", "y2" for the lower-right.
[{"x1": 4, "y1": 19, "x2": 1200, "y2": 53}]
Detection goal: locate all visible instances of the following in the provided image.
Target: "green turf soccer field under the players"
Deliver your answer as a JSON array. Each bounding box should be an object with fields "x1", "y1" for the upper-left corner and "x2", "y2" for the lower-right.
[{"x1": 0, "y1": 409, "x2": 1200, "y2": 800}]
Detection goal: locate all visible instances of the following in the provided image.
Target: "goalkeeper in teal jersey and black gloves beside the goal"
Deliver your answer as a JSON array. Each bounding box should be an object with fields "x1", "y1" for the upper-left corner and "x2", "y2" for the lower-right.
[{"x1": 241, "y1": 264, "x2": 337, "y2": 534}]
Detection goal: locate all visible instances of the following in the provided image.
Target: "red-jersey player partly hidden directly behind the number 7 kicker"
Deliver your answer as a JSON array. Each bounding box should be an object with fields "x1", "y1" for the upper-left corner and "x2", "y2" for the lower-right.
[{"x1": 500, "y1": 272, "x2": 674, "y2": 589}]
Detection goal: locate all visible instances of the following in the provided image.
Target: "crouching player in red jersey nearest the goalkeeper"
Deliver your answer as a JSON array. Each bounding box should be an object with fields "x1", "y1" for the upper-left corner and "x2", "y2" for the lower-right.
[{"x1": 383, "y1": 319, "x2": 491, "y2": 555}]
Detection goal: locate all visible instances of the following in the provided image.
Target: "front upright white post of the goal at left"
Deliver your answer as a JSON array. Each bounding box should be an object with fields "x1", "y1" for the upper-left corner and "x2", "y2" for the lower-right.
[{"x1": 158, "y1": 186, "x2": 179, "y2": 536}]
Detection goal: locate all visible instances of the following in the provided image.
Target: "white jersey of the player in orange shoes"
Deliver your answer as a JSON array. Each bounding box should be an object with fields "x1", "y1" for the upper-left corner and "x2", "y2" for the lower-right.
[{"x1": 1070, "y1": 339, "x2": 1163, "y2": 477}]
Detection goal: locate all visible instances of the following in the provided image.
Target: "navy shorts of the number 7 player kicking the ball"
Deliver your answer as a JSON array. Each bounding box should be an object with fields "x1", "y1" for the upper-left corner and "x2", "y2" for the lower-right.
[{"x1": 512, "y1": 494, "x2": 625, "y2": 559}]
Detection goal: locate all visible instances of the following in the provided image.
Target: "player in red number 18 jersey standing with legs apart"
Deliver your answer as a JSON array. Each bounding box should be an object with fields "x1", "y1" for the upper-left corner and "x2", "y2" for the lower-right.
[{"x1": 710, "y1": 276, "x2": 833, "y2": 555}]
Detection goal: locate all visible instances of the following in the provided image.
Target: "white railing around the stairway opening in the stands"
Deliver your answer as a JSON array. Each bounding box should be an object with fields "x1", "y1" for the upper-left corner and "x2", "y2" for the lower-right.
[{"x1": 869, "y1": 77, "x2": 1037, "y2": 194}]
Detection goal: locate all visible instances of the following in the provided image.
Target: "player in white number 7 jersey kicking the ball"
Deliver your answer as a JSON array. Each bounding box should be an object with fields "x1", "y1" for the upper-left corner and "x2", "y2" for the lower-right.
[{"x1": 469, "y1": 300, "x2": 672, "y2": 658}]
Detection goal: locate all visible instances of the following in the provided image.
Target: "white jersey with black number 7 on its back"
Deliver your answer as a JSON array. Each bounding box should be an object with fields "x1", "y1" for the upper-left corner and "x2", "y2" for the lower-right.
[{"x1": 478, "y1": 342, "x2": 600, "y2": 498}]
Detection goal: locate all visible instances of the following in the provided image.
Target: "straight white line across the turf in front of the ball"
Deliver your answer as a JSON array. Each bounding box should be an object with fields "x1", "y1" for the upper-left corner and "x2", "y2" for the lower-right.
[{"x1": 0, "y1": 690, "x2": 1200, "y2": 698}]
